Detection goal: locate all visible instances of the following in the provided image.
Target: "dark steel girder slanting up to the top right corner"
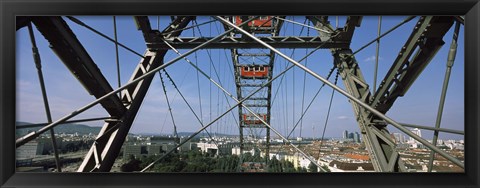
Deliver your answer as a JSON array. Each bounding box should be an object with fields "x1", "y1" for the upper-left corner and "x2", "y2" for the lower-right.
[{"x1": 370, "y1": 16, "x2": 454, "y2": 113}]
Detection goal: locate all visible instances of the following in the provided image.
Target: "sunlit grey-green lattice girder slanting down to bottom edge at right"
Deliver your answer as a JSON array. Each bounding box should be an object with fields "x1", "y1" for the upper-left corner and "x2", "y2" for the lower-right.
[{"x1": 333, "y1": 49, "x2": 405, "y2": 172}]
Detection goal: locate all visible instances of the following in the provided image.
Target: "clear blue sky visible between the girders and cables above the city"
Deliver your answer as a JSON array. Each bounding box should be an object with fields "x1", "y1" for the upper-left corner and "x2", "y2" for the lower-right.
[{"x1": 16, "y1": 16, "x2": 464, "y2": 139}]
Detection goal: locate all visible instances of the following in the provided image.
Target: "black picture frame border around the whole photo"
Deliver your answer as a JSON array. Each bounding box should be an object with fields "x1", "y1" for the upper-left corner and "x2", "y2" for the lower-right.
[{"x1": 0, "y1": 0, "x2": 480, "y2": 188}]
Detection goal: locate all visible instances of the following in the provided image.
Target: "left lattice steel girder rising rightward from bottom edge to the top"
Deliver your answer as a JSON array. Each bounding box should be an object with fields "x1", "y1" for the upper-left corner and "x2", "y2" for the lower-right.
[{"x1": 78, "y1": 17, "x2": 193, "y2": 172}]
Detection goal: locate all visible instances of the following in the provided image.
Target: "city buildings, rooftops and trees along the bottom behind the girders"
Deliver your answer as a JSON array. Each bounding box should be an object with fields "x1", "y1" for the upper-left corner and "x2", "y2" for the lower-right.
[{"x1": 16, "y1": 127, "x2": 464, "y2": 172}]
